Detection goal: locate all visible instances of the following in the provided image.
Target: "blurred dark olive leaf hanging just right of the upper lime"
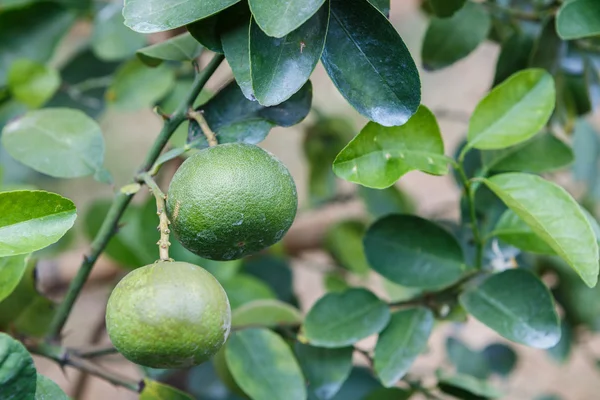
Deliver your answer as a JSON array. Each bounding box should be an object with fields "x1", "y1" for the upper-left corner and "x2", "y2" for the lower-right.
[{"x1": 303, "y1": 117, "x2": 354, "y2": 206}]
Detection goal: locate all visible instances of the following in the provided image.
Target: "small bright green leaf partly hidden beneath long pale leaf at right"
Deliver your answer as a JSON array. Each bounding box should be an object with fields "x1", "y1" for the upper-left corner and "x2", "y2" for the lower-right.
[{"x1": 492, "y1": 210, "x2": 556, "y2": 255}]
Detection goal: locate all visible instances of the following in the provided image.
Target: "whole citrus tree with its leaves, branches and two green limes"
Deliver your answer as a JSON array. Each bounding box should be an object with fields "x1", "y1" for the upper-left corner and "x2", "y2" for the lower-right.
[{"x1": 0, "y1": 0, "x2": 600, "y2": 400}]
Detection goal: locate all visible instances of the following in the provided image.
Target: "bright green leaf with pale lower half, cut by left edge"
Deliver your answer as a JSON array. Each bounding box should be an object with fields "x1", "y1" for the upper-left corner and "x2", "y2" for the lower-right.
[{"x1": 0, "y1": 190, "x2": 77, "y2": 257}]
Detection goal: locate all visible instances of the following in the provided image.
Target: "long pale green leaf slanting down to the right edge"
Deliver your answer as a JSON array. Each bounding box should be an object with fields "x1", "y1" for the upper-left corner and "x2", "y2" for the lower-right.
[{"x1": 484, "y1": 173, "x2": 599, "y2": 287}]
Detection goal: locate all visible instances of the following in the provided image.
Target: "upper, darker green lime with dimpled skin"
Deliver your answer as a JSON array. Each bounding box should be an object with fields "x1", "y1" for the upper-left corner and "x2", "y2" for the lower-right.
[{"x1": 167, "y1": 143, "x2": 298, "y2": 261}]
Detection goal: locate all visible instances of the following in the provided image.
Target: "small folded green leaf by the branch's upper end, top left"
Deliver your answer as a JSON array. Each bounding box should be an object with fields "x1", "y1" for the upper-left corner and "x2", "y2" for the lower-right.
[{"x1": 137, "y1": 33, "x2": 203, "y2": 67}]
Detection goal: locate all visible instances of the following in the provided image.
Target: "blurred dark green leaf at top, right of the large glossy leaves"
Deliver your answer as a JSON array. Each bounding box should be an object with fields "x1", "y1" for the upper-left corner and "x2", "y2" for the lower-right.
[{"x1": 421, "y1": 0, "x2": 491, "y2": 71}]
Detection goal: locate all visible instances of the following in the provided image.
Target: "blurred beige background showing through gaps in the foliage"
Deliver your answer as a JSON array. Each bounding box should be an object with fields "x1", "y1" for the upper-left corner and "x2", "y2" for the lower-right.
[{"x1": 0, "y1": 0, "x2": 600, "y2": 400}]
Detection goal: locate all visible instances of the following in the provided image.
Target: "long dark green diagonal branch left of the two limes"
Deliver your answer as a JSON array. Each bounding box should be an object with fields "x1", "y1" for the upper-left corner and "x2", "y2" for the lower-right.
[{"x1": 47, "y1": 54, "x2": 225, "y2": 340}]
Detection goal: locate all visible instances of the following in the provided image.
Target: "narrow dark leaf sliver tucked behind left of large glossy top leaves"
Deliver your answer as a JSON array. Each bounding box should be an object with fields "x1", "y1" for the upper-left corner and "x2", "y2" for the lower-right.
[{"x1": 217, "y1": 3, "x2": 253, "y2": 101}]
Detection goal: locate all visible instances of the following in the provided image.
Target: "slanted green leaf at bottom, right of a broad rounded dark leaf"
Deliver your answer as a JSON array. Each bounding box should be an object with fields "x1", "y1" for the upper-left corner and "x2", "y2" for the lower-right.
[{"x1": 374, "y1": 308, "x2": 434, "y2": 387}]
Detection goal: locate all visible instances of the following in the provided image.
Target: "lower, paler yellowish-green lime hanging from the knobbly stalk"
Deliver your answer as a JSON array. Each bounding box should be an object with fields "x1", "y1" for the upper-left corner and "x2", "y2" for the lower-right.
[{"x1": 106, "y1": 261, "x2": 231, "y2": 368}]
